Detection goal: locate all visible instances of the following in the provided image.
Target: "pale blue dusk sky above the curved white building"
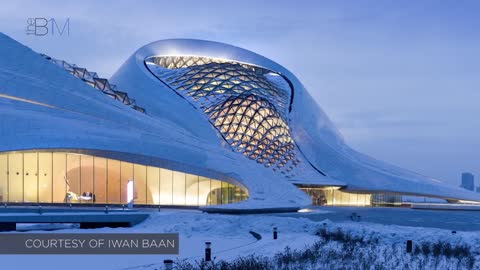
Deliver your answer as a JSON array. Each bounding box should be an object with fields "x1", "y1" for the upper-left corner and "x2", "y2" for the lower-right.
[{"x1": 0, "y1": 0, "x2": 480, "y2": 185}]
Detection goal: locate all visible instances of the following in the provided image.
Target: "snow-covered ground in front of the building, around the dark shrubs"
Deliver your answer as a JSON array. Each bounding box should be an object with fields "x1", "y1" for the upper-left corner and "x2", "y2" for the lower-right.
[{"x1": 0, "y1": 208, "x2": 480, "y2": 270}]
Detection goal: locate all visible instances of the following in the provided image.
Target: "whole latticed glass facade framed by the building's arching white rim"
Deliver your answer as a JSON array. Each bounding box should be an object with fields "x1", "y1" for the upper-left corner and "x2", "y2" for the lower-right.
[{"x1": 146, "y1": 56, "x2": 300, "y2": 177}]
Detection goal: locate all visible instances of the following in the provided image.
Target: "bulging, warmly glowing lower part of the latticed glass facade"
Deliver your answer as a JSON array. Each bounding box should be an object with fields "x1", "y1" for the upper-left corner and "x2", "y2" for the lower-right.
[{"x1": 209, "y1": 95, "x2": 299, "y2": 172}]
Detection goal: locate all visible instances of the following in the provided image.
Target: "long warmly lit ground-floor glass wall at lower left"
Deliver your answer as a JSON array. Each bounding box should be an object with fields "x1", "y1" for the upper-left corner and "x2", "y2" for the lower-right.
[{"x1": 0, "y1": 151, "x2": 248, "y2": 206}]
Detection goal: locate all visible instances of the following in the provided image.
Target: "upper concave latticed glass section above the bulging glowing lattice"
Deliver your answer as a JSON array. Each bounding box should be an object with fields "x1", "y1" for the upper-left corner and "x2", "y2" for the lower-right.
[{"x1": 147, "y1": 56, "x2": 291, "y2": 115}]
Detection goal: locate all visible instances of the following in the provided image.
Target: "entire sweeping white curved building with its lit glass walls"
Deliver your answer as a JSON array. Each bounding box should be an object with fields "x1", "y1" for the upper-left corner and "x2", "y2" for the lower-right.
[{"x1": 0, "y1": 35, "x2": 480, "y2": 211}]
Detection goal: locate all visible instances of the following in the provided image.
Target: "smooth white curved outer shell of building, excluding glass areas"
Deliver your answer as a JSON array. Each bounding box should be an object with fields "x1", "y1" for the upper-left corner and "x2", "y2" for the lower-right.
[{"x1": 0, "y1": 32, "x2": 480, "y2": 208}]
